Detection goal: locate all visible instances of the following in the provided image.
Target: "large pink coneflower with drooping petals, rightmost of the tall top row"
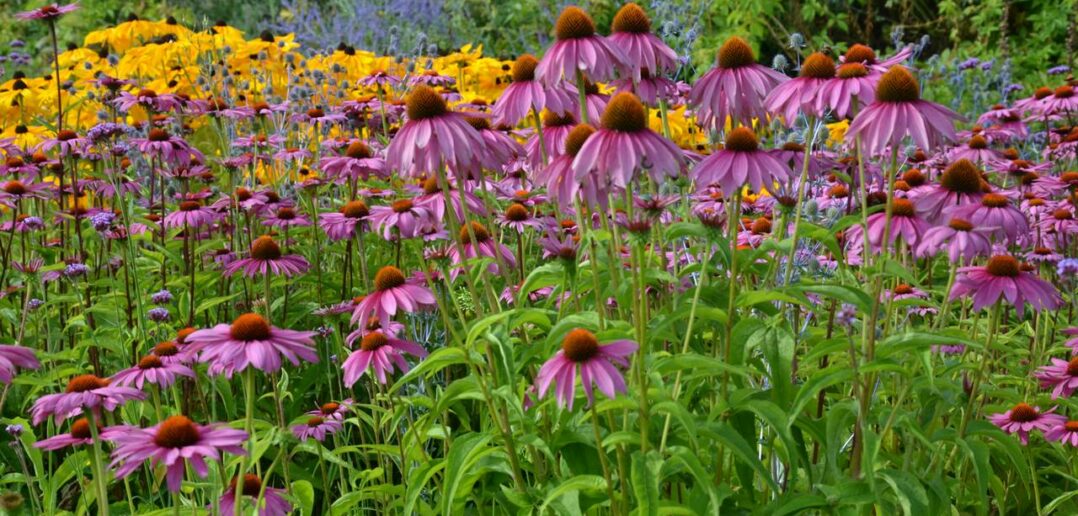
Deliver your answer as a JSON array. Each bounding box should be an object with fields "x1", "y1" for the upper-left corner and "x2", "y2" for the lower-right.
[{"x1": 846, "y1": 66, "x2": 962, "y2": 154}]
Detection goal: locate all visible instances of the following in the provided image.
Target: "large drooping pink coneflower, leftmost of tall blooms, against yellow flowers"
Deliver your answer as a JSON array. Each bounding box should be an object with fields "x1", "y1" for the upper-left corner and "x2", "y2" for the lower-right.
[{"x1": 386, "y1": 85, "x2": 493, "y2": 178}]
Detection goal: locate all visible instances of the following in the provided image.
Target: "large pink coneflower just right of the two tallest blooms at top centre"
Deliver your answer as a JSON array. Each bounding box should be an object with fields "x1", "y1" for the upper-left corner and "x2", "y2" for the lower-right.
[{"x1": 689, "y1": 36, "x2": 787, "y2": 129}]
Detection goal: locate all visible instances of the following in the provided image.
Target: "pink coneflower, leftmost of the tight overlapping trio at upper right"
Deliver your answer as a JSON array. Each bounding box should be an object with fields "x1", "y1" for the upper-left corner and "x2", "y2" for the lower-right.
[{"x1": 763, "y1": 52, "x2": 834, "y2": 127}]
